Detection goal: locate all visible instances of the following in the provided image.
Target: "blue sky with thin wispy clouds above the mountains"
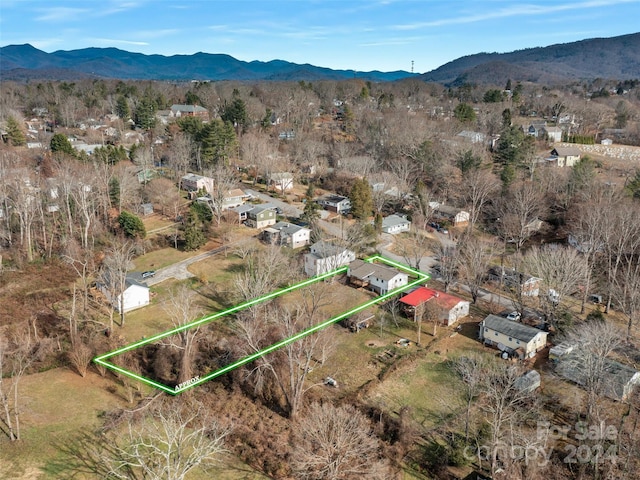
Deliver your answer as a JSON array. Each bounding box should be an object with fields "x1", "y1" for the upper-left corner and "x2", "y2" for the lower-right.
[{"x1": 0, "y1": 0, "x2": 640, "y2": 73}]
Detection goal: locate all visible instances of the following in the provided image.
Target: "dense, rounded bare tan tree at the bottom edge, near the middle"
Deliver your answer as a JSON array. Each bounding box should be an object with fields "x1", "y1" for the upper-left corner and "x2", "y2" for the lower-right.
[{"x1": 291, "y1": 403, "x2": 391, "y2": 480}]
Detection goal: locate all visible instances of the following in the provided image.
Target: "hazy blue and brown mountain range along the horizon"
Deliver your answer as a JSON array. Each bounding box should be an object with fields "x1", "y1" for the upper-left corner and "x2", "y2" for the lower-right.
[{"x1": 0, "y1": 33, "x2": 640, "y2": 86}]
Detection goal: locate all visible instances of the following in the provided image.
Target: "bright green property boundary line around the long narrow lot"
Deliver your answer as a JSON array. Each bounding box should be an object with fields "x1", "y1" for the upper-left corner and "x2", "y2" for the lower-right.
[{"x1": 93, "y1": 255, "x2": 430, "y2": 395}]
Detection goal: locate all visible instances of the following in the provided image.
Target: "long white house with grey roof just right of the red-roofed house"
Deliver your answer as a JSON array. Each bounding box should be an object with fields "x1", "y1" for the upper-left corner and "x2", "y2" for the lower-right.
[{"x1": 479, "y1": 315, "x2": 547, "y2": 359}]
